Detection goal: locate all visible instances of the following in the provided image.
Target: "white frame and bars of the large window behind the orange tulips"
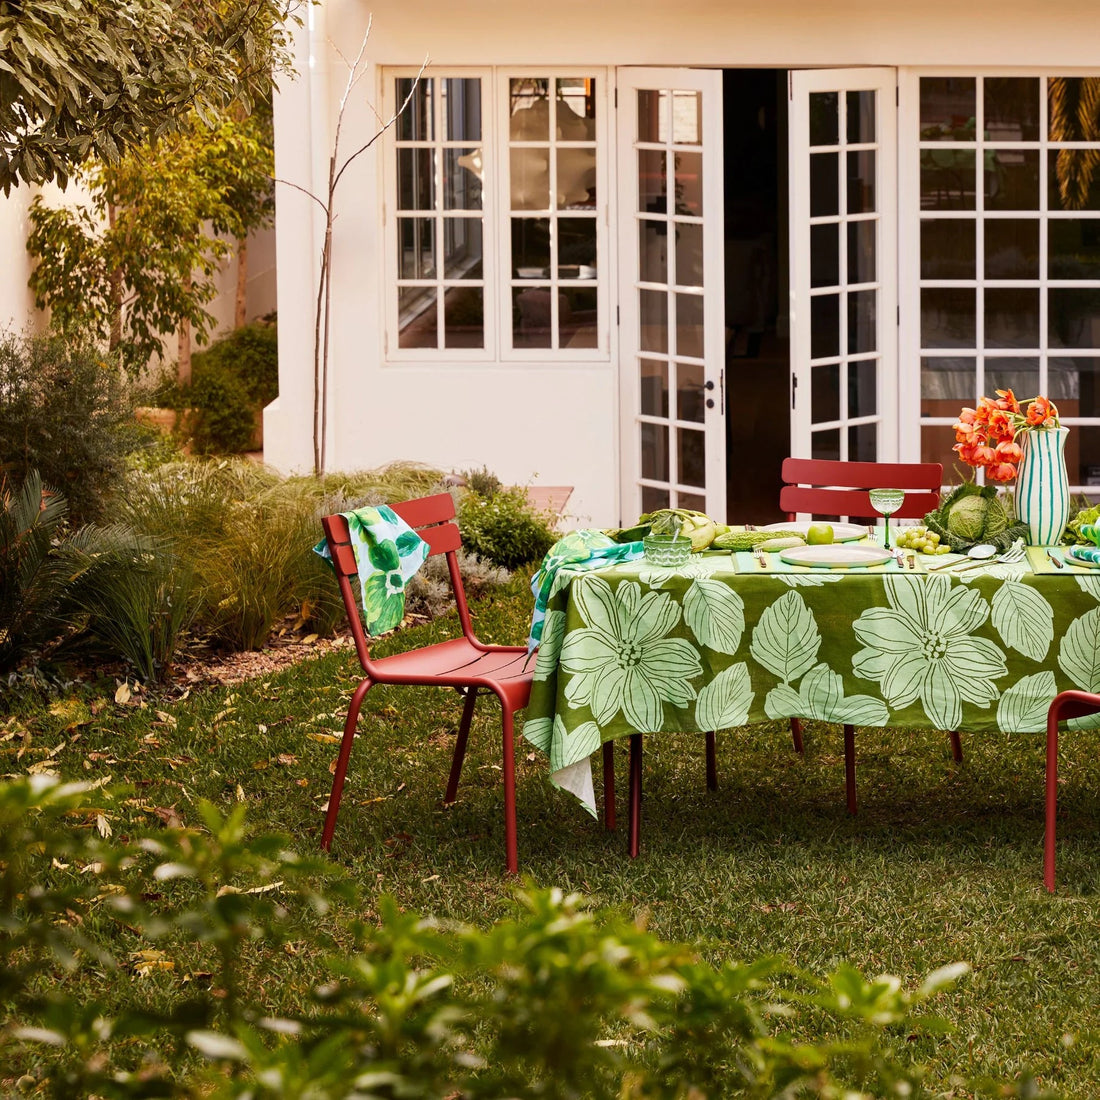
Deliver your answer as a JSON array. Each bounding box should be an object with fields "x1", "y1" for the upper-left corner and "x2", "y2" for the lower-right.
[{"x1": 898, "y1": 65, "x2": 1100, "y2": 484}]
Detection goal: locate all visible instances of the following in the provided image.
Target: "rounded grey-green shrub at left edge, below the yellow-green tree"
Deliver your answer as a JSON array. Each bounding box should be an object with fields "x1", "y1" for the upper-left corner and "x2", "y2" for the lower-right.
[{"x1": 0, "y1": 332, "x2": 141, "y2": 523}]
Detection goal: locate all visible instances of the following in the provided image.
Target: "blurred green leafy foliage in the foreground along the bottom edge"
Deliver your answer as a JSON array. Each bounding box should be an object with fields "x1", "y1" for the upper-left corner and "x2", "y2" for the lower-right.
[{"x1": 0, "y1": 776, "x2": 998, "y2": 1100}]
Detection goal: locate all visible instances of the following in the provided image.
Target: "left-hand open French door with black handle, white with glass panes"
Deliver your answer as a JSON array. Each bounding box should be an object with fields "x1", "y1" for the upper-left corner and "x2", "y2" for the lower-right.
[{"x1": 617, "y1": 68, "x2": 726, "y2": 523}]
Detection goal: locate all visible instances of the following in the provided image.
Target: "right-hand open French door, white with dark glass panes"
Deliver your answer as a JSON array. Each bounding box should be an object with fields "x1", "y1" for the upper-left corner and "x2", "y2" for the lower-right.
[{"x1": 789, "y1": 68, "x2": 898, "y2": 462}]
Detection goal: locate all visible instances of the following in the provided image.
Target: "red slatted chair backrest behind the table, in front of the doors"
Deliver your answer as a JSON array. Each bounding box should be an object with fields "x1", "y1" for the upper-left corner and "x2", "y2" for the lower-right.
[{"x1": 779, "y1": 459, "x2": 944, "y2": 519}]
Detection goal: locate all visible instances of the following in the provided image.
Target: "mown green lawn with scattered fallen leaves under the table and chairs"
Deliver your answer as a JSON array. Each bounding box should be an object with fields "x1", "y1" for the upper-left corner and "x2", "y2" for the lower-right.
[{"x1": 8, "y1": 575, "x2": 1100, "y2": 1098}]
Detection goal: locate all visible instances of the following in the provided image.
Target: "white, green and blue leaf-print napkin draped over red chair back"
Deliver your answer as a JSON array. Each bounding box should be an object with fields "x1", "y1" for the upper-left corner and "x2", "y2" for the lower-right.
[{"x1": 314, "y1": 505, "x2": 428, "y2": 638}]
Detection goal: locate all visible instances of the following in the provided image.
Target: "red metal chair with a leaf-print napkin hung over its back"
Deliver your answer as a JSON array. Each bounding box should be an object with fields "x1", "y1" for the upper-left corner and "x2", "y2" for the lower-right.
[{"x1": 321, "y1": 493, "x2": 558, "y2": 875}]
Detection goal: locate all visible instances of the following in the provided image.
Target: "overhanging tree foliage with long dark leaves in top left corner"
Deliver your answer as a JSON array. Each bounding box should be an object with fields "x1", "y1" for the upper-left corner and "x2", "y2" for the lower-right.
[{"x1": 0, "y1": 0, "x2": 300, "y2": 194}]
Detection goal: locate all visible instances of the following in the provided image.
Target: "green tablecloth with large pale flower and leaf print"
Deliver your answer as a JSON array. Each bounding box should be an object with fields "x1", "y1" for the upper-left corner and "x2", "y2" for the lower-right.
[{"x1": 524, "y1": 556, "x2": 1100, "y2": 813}]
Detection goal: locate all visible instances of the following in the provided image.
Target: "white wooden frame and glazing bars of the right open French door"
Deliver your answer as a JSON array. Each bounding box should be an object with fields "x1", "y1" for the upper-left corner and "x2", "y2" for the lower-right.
[{"x1": 789, "y1": 67, "x2": 902, "y2": 462}]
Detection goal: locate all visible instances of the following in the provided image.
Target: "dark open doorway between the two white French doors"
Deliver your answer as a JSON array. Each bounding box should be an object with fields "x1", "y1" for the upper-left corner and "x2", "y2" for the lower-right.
[{"x1": 723, "y1": 69, "x2": 791, "y2": 524}]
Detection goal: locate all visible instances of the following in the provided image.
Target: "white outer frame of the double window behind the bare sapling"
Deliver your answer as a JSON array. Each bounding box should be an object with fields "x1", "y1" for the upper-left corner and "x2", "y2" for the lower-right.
[{"x1": 378, "y1": 65, "x2": 615, "y2": 366}]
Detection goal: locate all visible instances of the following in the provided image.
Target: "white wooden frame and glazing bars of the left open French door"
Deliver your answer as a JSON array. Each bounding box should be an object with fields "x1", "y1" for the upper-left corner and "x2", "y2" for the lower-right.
[{"x1": 616, "y1": 67, "x2": 726, "y2": 524}]
